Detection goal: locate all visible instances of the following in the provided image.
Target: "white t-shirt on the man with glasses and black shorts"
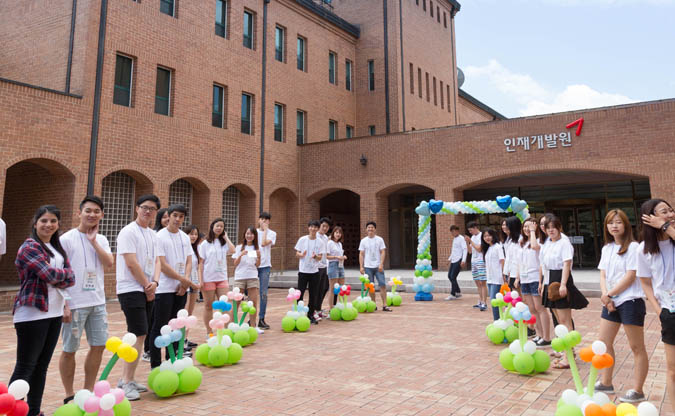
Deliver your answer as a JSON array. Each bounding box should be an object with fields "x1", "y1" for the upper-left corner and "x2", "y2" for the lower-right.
[{"x1": 115, "y1": 221, "x2": 157, "y2": 295}]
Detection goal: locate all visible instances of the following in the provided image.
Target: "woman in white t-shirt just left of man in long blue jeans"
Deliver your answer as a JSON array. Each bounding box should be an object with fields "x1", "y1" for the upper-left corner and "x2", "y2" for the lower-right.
[{"x1": 232, "y1": 227, "x2": 265, "y2": 334}]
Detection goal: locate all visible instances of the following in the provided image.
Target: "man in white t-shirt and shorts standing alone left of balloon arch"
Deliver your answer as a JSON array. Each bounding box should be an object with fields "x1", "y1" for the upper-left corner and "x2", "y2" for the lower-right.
[{"x1": 359, "y1": 221, "x2": 391, "y2": 312}]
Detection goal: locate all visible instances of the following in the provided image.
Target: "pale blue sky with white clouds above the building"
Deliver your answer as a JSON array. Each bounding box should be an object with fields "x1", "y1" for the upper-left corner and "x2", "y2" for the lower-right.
[{"x1": 455, "y1": 0, "x2": 675, "y2": 118}]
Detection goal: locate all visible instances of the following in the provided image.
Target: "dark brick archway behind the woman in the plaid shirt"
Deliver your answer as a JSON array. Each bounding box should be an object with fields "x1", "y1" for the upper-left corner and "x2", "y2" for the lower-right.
[{"x1": 0, "y1": 159, "x2": 75, "y2": 284}]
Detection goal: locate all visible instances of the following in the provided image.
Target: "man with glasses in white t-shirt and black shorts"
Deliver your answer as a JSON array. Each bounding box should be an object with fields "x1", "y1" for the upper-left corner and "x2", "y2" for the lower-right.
[{"x1": 116, "y1": 195, "x2": 160, "y2": 400}]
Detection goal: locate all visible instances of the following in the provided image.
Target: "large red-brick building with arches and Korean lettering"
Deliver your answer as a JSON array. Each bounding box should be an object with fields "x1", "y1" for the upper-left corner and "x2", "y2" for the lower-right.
[{"x1": 0, "y1": 0, "x2": 675, "y2": 308}]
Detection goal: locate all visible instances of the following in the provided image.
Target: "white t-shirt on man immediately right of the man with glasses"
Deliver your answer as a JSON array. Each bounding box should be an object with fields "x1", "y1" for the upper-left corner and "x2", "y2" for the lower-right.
[{"x1": 156, "y1": 228, "x2": 195, "y2": 293}]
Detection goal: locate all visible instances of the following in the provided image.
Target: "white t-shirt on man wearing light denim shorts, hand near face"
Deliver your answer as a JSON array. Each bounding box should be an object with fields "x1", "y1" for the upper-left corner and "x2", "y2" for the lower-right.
[{"x1": 59, "y1": 228, "x2": 110, "y2": 309}]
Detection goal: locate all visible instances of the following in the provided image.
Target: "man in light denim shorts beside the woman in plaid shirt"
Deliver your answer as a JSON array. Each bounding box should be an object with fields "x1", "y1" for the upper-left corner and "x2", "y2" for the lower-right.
[{"x1": 59, "y1": 196, "x2": 113, "y2": 403}]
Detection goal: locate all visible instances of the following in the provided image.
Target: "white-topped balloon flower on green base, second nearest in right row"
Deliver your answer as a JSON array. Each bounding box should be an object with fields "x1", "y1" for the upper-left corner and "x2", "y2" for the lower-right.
[{"x1": 499, "y1": 302, "x2": 551, "y2": 375}]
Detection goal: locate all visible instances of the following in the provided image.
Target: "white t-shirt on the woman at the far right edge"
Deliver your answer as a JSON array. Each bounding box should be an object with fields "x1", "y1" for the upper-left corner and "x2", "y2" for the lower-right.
[{"x1": 637, "y1": 239, "x2": 675, "y2": 312}]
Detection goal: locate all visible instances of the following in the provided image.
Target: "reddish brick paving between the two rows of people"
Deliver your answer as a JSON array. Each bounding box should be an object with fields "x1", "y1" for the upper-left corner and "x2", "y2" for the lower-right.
[{"x1": 0, "y1": 290, "x2": 670, "y2": 416}]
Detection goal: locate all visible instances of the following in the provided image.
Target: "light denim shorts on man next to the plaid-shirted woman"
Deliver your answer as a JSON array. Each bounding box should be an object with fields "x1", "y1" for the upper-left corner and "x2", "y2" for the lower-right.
[{"x1": 61, "y1": 305, "x2": 108, "y2": 352}]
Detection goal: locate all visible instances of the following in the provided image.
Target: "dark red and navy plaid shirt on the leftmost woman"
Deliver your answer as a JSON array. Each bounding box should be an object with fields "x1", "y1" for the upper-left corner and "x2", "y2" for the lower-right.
[{"x1": 12, "y1": 238, "x2": 75, "y2": 313}]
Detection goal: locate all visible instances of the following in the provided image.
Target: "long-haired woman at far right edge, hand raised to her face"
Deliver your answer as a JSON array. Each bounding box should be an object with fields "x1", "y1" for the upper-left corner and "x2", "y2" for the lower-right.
[{"x1": 637, "y1": 199, "x2": 675, "y2": 414}]
